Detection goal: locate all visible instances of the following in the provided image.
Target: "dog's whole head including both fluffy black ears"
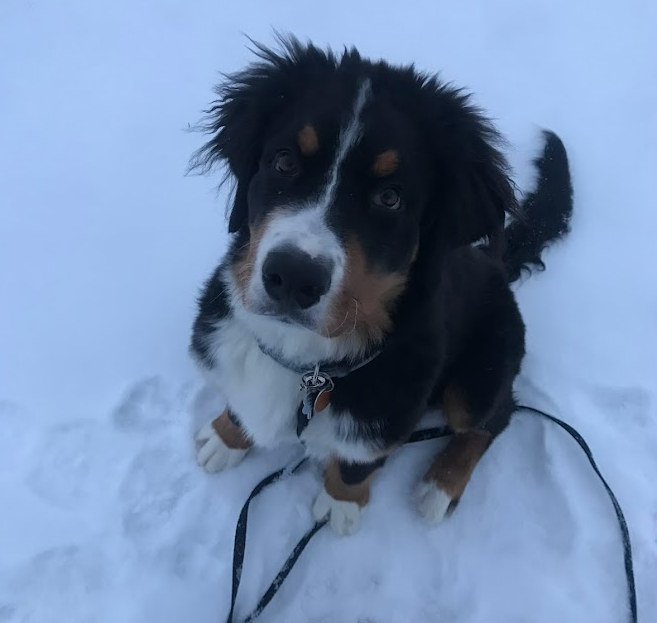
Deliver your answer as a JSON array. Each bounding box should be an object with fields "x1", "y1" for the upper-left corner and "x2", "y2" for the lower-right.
[{"x1": 193, "y1": 40, "x2": 515, "y2": 352}]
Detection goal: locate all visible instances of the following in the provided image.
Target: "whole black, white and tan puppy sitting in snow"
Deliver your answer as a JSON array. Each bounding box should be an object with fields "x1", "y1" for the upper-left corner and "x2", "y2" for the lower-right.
[{"x1": 191, "y1": 39, "x2": 572, "y2": 534}]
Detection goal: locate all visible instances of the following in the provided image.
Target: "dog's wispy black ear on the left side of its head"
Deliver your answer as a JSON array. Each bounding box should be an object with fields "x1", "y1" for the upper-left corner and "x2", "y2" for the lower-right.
[{"x1": 190, "y1": 37, "x2": 335, "y2": 233}]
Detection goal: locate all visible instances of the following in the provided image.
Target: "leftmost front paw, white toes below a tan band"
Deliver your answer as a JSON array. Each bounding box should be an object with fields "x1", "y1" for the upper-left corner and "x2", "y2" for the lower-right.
[{"x1": 196, "y1": 409, "x2": 253, "y2": 473}]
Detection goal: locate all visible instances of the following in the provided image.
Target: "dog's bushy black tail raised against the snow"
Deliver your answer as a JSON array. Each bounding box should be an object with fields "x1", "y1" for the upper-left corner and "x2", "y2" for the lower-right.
[{"x1": 503, "y1": 130, "x2": 573, "y2": 282}]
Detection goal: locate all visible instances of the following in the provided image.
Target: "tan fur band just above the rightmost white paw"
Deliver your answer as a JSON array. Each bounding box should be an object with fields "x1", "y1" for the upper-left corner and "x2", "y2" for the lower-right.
[{"x1": 424, "y1": 431, "x2": 491, "y2": 501}]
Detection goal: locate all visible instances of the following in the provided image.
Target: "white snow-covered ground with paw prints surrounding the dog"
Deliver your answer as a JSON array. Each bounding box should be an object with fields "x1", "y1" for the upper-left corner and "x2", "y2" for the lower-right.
[{"x1": 0, "y1": 0, "x2": 657, "y2": 623}]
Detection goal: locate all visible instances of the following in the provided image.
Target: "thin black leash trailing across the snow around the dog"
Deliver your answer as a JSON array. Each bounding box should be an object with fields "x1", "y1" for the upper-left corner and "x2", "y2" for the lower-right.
[{"x1": 226, "y1": 406, "x2": 638, "y2": 623}]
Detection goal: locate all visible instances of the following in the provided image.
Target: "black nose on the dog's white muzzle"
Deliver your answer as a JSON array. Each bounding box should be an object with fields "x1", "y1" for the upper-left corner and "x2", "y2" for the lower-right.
[{"x1": 262, "y1": 248, "x2": 331, "y2": 309}]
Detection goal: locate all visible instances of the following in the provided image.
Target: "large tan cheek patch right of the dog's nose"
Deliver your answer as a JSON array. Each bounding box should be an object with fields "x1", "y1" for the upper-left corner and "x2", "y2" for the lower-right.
[{"x1": 326, "y1": 240, "x2": 407, "y2": 341}]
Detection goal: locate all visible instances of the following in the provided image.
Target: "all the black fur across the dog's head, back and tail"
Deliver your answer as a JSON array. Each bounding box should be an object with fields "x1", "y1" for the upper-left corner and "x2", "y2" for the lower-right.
[{"x1": 187, "y1": 40, "x2": 572, "y2": 468}]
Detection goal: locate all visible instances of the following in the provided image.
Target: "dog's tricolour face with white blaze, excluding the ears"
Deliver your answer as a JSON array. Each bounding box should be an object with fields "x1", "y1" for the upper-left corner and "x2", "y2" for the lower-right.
[{"x1": 234, "y1": 78, "x2": 429, "y2": 337}]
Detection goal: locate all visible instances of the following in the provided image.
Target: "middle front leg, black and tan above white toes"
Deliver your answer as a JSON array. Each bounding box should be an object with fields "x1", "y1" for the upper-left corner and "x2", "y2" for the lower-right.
[{"x1": 313, "y1": 458, "x2": 385, "y2": 536}]
